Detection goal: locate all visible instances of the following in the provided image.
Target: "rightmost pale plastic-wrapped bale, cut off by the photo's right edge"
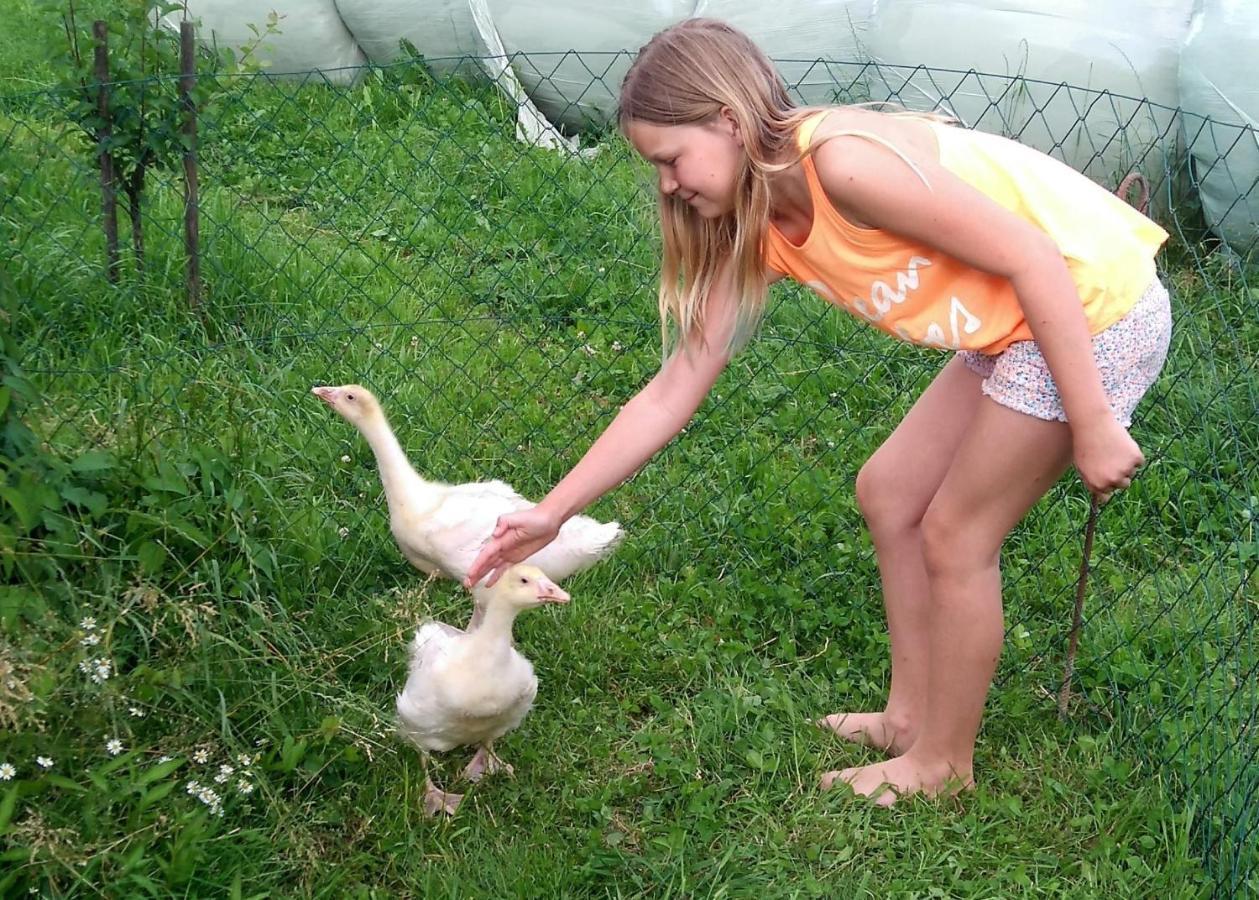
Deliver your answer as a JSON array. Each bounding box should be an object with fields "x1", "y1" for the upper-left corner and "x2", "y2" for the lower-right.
[{"x1": 1180, "y1": 0, "x2": 1259, "y2": 254}]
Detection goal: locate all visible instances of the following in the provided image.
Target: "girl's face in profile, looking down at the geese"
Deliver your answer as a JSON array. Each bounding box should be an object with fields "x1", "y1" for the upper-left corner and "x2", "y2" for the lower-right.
[{"x1": 626, "y1": 115, "x2": 743, "y2": 219}]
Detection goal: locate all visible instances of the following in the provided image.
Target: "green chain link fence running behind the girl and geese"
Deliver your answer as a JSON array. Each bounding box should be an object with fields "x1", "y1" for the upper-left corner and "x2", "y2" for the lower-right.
[{"x1": 0, "y1": 47, "x2": 1259, "y2": 895}]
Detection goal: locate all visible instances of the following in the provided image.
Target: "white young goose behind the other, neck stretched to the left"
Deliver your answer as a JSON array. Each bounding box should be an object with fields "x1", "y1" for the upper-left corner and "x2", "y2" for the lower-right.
[{"x1": 311, "y1": 384, "x2": 624, "y2": 582}]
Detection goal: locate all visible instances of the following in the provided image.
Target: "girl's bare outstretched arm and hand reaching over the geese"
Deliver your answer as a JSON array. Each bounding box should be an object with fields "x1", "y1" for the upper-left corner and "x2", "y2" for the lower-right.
[{"x1": 465, "y1": 265, "x2": 737, "y2": 587}]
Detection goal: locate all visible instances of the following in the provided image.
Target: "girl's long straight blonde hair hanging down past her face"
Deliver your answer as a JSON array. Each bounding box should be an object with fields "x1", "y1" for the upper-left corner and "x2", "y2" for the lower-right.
[{"x1": 618, "y1": 19, "x2": 946, "y2": 355}]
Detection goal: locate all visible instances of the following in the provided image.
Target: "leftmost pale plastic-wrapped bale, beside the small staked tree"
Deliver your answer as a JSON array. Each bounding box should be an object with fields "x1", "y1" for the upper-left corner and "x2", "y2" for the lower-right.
[{"x1": 177, "y1": 0, "x2": 368, "y2": 84}]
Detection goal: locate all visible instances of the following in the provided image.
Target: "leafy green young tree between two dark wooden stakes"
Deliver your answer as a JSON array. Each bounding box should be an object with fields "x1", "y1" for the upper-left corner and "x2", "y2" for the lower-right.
[{"x1": 45, "y1": 0, "x2": 278, "y2": 271}]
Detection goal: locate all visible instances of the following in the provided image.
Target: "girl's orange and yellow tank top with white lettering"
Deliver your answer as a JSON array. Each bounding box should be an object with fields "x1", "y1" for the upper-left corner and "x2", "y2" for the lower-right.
[{"x1": 764, "y1": 112, "x2": 1167, "y2": 354}]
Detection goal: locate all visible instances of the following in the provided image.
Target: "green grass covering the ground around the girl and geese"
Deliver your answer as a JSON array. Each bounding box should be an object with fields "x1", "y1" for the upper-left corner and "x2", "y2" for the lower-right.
[{"x1": 0, "y1": 5, "x2": 1259, "y2": 897}]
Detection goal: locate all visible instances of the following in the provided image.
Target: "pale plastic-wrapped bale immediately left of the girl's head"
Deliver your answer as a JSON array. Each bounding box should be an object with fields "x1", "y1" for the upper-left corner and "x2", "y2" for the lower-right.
[{"x1": 487, "y1": 0, "x2": 695, "y2": 128}]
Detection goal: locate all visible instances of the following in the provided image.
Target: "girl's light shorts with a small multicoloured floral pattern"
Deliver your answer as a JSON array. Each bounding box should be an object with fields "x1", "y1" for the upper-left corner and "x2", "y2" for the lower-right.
[{"x1": 961, "y1": 278, "x2": 1172, "y2": 428}]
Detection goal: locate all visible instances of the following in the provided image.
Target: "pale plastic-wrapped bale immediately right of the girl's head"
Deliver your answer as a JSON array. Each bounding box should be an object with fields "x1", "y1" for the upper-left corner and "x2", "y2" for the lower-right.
[{"x1": 695, "y1": 0, "x2": 875, "y2": 106}]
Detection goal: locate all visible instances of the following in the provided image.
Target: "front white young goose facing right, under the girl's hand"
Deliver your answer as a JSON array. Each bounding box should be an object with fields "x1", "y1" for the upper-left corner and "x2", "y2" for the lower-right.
[{"x1": 398, "y1": 564, "x2": 569, "y2": 816}]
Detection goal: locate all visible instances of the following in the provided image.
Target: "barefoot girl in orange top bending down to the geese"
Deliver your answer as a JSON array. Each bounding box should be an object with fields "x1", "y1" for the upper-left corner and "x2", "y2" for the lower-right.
[{"x1": 468, "y1": 19, "x2": 1171, "y2": 806}]
